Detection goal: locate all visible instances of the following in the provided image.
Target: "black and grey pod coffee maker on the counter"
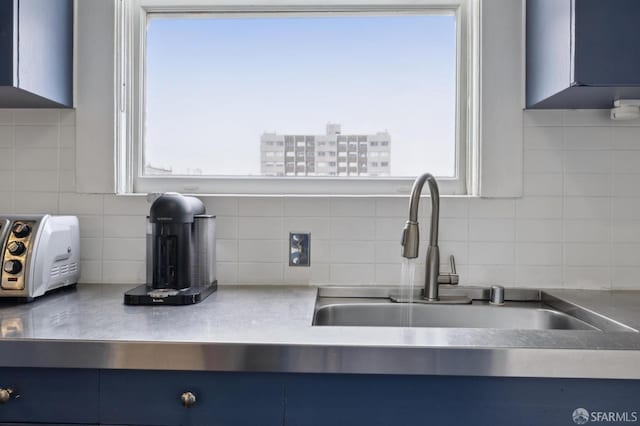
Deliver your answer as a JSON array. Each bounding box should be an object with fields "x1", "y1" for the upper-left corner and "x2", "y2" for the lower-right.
[{"x1": 124, "y1": 193, "x2": 218, "y2": 305}]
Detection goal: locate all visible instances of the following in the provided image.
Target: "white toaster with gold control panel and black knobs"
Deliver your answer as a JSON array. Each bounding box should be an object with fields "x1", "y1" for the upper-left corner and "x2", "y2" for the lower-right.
[{"x1": 0, "y1": 214, "x2": 80, "y2": 301}]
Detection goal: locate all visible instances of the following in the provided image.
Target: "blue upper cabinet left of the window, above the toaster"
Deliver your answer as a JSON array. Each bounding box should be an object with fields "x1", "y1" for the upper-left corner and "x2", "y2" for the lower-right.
[{"x1": 0, "y1": 0, "x2": 73, "y2": 108}]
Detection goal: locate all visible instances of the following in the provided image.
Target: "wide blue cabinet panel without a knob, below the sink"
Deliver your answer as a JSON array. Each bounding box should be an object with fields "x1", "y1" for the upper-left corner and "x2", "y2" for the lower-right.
[{"x1": 285, "y1": 374, "x2": 640, "y2": 426}]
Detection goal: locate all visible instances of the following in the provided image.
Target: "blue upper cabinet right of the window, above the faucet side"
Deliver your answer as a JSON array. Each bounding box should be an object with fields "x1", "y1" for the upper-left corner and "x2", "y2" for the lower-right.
[{"x1": 526, "y1": 0, "x2": 640, "y2": 109}]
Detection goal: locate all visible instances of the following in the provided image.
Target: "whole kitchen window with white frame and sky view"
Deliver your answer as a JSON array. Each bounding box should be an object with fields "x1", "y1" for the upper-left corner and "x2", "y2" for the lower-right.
[{"x1": 118, "y1": 0, "x2": 473, "y2": 195}]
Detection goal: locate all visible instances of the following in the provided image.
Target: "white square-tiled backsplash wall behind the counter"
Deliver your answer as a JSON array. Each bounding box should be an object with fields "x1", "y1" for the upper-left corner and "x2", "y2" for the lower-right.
[{"x1": 0, "y1": 106, "x2": 640, "y2": 289}]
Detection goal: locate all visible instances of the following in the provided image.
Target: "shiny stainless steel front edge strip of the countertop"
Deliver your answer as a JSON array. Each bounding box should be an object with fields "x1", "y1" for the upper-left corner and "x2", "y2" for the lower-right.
[{"x1": 0, "y1": 339, "x2": 640, "y2": 379}]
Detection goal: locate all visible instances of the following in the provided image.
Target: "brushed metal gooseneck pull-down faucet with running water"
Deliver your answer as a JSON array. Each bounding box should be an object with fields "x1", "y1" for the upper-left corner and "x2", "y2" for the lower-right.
[{"x1": 402, "y1": 173, "x2": 471, "y2": 303}]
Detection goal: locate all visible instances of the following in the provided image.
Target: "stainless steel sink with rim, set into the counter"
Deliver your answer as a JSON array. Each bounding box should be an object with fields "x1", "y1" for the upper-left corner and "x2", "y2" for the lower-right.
[{"x1": 313, "y1": 288, "x2": 636, "y2": 331}]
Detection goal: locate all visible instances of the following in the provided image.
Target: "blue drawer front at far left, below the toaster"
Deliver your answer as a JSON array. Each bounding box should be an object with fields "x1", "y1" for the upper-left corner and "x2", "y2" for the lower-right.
[{"x1": 0, "y1": 368, "x2": 98, "y2": 424}]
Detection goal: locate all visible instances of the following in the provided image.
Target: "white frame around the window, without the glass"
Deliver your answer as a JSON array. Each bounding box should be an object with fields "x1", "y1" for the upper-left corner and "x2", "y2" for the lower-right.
[{"x1": 116, "y1": 0, "x2": 478, "y2": 196}]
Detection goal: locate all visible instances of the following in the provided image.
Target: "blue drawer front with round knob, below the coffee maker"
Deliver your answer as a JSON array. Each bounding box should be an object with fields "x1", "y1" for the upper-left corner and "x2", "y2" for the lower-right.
[{"x1": 100, "y1": 370, "x2": 284, "y2": 426}]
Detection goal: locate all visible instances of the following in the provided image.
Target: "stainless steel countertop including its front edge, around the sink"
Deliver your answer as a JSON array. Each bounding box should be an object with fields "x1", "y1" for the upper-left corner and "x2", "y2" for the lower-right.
[{"x1": 0, "y1": 284, "x2": 640, "y2": 379}]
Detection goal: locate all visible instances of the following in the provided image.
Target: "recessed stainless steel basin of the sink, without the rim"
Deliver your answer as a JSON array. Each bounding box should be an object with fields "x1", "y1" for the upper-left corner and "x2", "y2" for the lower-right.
[{"x1": 314, "y1": 302, "x2": 599, "y2": 330}]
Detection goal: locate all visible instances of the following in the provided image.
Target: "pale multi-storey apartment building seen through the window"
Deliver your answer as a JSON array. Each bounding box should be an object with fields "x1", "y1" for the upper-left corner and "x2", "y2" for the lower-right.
[{"x1": 260, "y1": 123, "x2": 391, "y2": 176}]
